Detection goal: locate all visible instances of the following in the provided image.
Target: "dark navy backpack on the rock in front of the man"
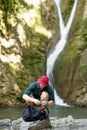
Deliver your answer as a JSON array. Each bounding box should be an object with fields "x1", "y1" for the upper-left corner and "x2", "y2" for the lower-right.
[{"x1": 22, "y1": 105, "x2": 49, "y2": 122}]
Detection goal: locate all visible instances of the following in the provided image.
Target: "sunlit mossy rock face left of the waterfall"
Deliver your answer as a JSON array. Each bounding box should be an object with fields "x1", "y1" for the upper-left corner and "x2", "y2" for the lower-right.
[{"x1": 0, "y1": 0, "x2": 58, "y2": 106}]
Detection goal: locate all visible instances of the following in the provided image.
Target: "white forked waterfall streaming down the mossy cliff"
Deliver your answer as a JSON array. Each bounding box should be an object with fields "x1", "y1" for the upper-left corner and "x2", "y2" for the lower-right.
[{"x1": 47, "y1": 0, "x2": 78, "y2": 105}]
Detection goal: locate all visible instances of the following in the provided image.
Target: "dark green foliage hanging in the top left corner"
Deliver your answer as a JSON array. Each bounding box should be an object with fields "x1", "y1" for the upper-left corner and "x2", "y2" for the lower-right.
[{"x1": 0, "y1": 0, "x2": 32, "y2": 31}]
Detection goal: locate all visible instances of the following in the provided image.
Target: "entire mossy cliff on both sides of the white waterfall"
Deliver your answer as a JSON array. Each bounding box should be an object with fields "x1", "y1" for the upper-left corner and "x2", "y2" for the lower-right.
[{"x1": 0, "y1": 0, "x2": 87, "y2": 106}]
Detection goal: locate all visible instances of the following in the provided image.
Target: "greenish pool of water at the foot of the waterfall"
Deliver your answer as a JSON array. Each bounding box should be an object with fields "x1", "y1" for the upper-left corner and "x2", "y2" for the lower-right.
[{"x1": 0, "y1": 105, "x2": 87, "y2": 120}]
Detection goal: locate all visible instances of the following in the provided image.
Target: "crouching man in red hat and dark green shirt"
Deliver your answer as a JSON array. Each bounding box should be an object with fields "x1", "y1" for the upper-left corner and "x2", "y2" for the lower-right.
[{"x1": 23, "y1": 75, "x2": 54, "y2": 107}]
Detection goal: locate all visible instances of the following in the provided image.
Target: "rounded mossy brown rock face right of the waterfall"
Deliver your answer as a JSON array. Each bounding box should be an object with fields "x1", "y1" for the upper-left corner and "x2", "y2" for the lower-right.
[{"x1": 53, "y1": 0, "x2": 87, "y2": 106}]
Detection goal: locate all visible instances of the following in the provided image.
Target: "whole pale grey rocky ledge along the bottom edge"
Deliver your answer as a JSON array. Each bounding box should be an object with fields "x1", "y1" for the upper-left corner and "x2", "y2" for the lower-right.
[{"x1": 0, "y1": 115, "x2": 87, "y2": 130}]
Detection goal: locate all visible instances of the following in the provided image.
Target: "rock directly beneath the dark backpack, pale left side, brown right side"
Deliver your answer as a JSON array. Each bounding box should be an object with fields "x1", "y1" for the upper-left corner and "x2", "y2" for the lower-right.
[{"x1": 12, "y1": 118, "x2": 51, "y2": 130}]
